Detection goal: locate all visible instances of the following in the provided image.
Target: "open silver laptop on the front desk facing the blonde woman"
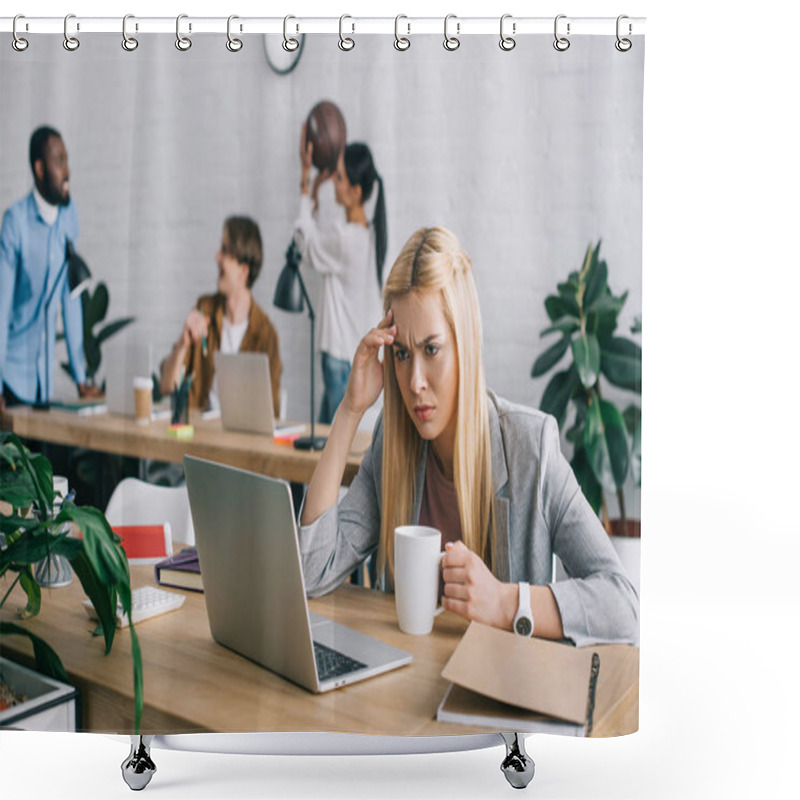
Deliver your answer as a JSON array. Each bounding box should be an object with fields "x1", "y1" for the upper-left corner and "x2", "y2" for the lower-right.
[{"x1": 183, "y1": 456, "x2": 412, "y2": 692}]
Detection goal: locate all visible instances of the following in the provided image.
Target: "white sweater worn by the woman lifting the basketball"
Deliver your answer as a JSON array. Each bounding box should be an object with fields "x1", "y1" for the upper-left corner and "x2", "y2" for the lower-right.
[{"x1": 295, "y1": 195, "x2": 382, "y2": 362}]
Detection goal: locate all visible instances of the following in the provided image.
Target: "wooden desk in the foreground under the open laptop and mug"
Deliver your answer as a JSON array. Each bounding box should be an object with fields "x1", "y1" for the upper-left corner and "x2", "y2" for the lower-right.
[{"x1": 0, "y1": 567, "x2": 638, "y2": 736}]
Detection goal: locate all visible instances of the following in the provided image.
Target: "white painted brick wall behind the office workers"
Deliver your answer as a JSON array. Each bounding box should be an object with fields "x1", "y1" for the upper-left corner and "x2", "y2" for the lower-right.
[{"x1": 0, "y1": 34, "x2": 644, "y2": 512}]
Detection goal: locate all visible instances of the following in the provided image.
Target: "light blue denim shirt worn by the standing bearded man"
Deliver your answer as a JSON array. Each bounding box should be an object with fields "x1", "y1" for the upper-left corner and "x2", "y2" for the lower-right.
[{"x1": 0, "y1": 192, "x2": 86, "y2": 402}]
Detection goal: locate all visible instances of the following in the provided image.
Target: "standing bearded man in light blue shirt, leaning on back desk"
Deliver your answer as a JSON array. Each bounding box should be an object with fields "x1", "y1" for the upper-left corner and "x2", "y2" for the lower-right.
[{"x1": 0, "y1": 126, "x2": 94, "y2": 407}]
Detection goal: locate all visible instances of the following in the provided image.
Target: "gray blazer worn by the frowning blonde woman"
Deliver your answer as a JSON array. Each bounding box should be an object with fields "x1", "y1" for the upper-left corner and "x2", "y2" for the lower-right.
[{"x1": 300, "y1": 392, "x2": 639, "y2": 645}]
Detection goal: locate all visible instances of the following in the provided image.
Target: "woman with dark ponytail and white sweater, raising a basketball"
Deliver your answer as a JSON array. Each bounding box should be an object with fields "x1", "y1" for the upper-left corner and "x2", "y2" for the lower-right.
[{"x1": 295, "y1": 118, "x2": 386, "y2": 423}]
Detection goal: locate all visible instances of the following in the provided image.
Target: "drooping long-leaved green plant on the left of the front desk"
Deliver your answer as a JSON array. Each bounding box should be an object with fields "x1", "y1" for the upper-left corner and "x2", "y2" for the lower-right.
[{"x1": 0, "y1": 431, "x2": 143, "y2": 731}]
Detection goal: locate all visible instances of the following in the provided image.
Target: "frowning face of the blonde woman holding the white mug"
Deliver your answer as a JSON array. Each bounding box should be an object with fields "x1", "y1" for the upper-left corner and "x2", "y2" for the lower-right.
[{"x1": 392, "y1": 292, "x2": 458, "y2": 452}]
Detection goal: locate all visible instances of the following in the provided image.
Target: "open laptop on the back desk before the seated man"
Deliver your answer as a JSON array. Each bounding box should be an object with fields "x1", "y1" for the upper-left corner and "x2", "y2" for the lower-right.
[{"x1": 214, "y1": 353, "x2": 275, "y2": 436}]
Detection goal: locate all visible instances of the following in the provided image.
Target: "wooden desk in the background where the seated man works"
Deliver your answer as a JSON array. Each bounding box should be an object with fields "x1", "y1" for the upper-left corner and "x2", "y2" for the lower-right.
[{"x1": 0, "y1": 406, "x2": 371, "y2": 485}]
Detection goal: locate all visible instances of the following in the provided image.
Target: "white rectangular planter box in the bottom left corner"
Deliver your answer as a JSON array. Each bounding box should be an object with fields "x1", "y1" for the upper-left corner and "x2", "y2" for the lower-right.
[{"x1": 0, "y1": 656, "x2": 78, "y2": 732}]
